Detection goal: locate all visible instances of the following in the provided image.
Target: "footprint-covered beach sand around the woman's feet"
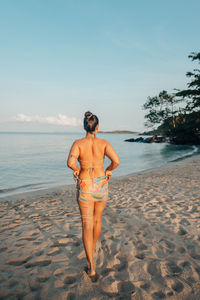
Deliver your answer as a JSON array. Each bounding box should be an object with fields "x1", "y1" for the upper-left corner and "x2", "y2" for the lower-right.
[{"x1": 0, "y1": 155, "x2": 200, "y2": 300}]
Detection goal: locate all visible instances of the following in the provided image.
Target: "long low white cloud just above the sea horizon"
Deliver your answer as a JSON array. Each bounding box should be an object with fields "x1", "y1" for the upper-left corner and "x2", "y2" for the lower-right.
[{"x1": 13, "y1": 114, "x2": 81, "y2": 126}]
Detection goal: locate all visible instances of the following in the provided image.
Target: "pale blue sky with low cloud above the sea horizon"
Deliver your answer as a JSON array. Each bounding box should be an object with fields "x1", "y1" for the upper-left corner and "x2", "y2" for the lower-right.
[{"x1": 0, "y1": 0, "x2": 200, "y2": 132}]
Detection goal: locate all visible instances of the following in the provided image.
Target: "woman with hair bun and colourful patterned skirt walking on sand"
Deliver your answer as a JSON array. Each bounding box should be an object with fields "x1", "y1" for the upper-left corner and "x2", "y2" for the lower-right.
[{"x1": 67, "y1": 112, "x2": 120, "y2": 282}]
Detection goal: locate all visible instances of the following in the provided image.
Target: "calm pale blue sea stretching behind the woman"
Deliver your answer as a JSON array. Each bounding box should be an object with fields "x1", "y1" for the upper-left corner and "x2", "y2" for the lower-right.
[{"x1": 0, "y1": 132, "x2": 198, "y2": 198}]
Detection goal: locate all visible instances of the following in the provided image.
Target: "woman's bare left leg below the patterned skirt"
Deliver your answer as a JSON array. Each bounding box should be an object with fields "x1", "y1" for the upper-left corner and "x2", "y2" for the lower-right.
[{"x1": 78, "y1": 199, "x2": 95, "y2": 275}]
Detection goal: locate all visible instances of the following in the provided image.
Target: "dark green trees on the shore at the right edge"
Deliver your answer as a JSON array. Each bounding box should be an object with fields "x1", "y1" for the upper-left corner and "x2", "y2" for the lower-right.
[{"x1": 143, "y1": 52, "x2": 200, "y2": 140}]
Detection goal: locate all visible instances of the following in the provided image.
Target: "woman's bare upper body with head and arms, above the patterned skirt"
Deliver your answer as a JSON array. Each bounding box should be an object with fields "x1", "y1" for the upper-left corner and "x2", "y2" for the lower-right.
[{"x1": 67, "y1": 112, "x2": 120, "y2": 180}]
